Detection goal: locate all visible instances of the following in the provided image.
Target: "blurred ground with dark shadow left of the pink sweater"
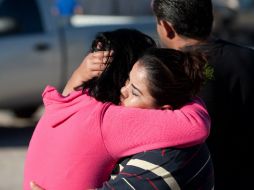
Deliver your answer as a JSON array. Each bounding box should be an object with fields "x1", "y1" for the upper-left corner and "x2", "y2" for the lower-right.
[{"x1": 0, "y1": 110, "x2": 39, "y2": 190}]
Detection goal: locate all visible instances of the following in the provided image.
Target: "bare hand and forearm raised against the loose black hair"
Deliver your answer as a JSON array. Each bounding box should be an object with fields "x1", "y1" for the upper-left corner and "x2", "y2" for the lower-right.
[{"x1": 62, "y1": 51, "x2": 112, "y2": 96}]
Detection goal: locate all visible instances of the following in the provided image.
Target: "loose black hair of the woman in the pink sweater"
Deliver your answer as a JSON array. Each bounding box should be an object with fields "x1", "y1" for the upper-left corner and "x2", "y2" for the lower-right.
[{"x1": 78, "y1": 29, "x2": 156, "y2": 104}]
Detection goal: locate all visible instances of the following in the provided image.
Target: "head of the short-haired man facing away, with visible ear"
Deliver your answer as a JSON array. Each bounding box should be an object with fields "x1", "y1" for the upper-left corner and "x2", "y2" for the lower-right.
[{"x1": 152, "y1": 0, "x2": 213, "y2": 46}]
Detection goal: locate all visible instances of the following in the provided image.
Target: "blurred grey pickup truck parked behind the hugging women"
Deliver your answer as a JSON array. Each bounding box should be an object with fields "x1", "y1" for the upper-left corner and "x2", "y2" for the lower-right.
[{"x1": 0, "y1": 0, "x2": 156, "y2": 116}]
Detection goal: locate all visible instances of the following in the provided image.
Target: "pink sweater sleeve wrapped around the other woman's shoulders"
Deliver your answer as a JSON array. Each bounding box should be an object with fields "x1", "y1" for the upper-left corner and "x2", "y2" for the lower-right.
[{"x1": 101, "y1": 98, "x2": 210, "y2": 159}]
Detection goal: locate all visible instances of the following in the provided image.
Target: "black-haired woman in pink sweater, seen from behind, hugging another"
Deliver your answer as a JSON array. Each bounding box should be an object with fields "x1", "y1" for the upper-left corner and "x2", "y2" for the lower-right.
[{"x1": 24, "y1": 30, "x2": 210, "y2": 190}]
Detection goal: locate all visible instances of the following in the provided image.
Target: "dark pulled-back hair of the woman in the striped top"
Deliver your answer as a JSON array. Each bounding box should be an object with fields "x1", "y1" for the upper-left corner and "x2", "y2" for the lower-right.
[{"x1": 139, "y1": 48, "x2": 213, "y2": 109}]
